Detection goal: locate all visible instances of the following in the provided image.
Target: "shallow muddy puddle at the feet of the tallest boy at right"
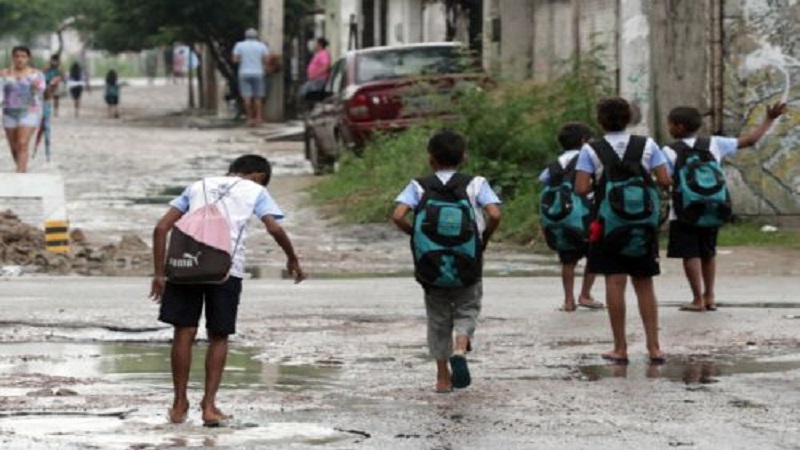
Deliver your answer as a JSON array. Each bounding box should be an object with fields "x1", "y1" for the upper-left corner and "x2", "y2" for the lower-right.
[{"x1": 574, "y1": 354, "x2": 800, "y2": 385}]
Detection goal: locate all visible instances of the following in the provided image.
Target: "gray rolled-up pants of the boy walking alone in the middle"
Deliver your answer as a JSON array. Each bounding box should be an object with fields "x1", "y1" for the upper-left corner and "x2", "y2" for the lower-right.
[{"x1": 425, "y1": 281, "x2": 483, "y2": 360}]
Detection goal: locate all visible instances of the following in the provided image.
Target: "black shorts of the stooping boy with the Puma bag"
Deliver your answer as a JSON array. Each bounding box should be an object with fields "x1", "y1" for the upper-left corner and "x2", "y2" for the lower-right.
[{"x1": 158, "y1": 277, "x2": 242, "y2": 335}]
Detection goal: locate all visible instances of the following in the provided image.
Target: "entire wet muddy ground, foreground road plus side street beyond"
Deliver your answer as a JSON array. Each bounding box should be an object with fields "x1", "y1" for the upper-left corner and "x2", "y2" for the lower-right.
[{"x1": 0, "y1": 81, "x2": 800, "y2": 449}]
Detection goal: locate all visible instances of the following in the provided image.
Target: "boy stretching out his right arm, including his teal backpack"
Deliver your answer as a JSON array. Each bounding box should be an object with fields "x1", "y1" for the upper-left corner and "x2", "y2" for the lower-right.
[{"x1": 664, "y1": 103, "x2": 786, "y2": 312}]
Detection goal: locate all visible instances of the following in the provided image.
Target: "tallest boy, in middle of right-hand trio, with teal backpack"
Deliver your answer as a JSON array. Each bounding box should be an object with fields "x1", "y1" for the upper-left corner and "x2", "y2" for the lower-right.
[{"x1": 575, "y1": 97, "x2": 672, "y2": 365}]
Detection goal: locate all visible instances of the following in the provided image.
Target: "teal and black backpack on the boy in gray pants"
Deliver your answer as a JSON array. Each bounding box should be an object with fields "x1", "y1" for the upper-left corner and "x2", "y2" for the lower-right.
[{"x1": 411, "y1": 173, "x2": 483, "y2": 288}]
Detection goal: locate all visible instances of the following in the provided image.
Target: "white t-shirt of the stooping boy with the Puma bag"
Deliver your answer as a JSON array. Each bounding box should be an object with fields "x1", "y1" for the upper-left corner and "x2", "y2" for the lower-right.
[{"x1": 169, "y1": 176, "x2": 283, "y2": 278}]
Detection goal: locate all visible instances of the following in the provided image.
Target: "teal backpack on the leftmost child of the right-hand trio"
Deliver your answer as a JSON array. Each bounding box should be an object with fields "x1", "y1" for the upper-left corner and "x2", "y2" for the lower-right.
[{"x1": 539, "y1": 155, "x2": 592, "y2": 252}]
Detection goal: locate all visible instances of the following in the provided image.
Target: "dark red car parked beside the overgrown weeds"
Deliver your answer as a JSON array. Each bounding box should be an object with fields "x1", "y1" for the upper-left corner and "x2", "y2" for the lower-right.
[{"x1": 305, "y1": 42, "x2": 488, "y2": 174}]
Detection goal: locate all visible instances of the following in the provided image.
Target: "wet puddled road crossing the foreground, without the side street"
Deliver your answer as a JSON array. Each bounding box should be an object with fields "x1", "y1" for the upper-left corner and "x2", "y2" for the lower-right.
[{"x1": 0, "y1": 276, "x2": 800, "y2": 449}]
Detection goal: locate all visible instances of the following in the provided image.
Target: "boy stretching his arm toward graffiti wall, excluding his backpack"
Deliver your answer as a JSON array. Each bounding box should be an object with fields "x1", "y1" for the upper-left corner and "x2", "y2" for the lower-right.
[{"x1": 664, "y1": 103, "x2": 786, "y2": 312}]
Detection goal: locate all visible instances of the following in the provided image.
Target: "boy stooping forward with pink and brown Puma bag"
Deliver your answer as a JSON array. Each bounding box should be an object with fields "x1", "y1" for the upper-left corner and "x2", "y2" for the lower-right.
[{"x1": 150, "y1": 155, "x2": 306, "y2": 427}]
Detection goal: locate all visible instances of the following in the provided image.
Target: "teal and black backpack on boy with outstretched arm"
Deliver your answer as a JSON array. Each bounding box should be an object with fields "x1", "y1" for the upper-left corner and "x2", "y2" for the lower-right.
[{"x1": 669, "y1": 138, "x2": 732, "y2": 227}]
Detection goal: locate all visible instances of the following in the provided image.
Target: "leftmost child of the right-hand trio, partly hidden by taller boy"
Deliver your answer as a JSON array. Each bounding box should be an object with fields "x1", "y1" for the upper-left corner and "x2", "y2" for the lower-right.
[{"x1": 539, "y1": 122, "x2": 603, "y2": 312}]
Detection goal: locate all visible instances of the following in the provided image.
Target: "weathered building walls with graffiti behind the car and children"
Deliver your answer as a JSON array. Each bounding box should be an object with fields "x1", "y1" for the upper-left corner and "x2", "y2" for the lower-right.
[{"x1": 316, "y1": 0, "x2": 800, "y2": 216}]
